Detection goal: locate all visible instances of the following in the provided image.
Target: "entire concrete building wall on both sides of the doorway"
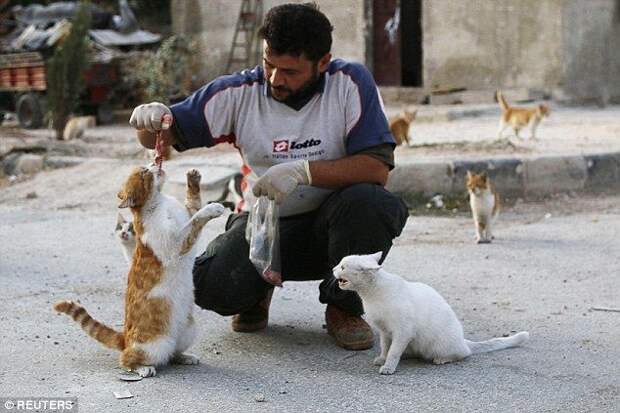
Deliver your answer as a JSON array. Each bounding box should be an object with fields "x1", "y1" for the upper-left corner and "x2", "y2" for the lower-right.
[{"x1": 171, "y1": 0, "x2": 620, "y2": 101}]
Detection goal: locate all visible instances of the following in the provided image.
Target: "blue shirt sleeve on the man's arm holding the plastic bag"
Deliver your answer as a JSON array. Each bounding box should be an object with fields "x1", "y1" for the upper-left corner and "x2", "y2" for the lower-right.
[{"x1": 342, "y1": 63, "x2": 396, "y2": 155}]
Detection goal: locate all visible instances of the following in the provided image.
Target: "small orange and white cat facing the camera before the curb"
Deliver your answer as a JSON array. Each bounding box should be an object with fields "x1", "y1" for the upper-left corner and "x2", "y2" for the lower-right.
[{"x1": 467, "y1": 171, "x2": 500, "y2": 244}]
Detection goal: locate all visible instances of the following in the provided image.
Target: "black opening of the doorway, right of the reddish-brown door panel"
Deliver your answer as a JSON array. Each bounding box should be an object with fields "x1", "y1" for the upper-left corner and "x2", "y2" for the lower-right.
[{"x1": 400, "y1": 0, "x2": 422, "y2": 87}]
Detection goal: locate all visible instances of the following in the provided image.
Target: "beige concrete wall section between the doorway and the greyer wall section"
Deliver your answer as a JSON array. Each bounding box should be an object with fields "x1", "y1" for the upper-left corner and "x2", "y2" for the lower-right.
[{"x1": 422, "y1": 0, "x2": 560, "y2": 89}]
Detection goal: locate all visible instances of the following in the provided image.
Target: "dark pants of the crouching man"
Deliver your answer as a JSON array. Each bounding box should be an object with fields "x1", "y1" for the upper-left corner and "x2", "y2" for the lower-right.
[{"x1": 194, "y1": 184, "x2": 408, "y2": 315}]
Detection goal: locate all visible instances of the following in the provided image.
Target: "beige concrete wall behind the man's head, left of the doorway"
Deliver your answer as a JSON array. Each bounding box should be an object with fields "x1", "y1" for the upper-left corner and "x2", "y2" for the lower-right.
[{"x1": 171, "y1": 0, "x2": 366, "y2": 81}]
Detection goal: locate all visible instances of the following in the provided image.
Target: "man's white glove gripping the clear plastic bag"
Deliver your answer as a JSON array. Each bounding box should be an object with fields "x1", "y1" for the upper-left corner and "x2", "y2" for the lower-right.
[{"x1": 252, "y1": 161, "x2": 312, "y2": 204}]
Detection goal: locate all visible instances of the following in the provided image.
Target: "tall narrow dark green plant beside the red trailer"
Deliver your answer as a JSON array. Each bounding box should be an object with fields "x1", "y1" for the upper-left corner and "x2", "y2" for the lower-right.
[{"x1": 47, "y1": 2, "x2": 91, "y2": 139}]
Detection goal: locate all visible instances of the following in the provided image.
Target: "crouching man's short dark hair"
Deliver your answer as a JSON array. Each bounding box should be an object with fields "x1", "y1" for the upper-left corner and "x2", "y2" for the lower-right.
[{"x1": 258, "y1": 3, "x2": 334, "y2": 62}]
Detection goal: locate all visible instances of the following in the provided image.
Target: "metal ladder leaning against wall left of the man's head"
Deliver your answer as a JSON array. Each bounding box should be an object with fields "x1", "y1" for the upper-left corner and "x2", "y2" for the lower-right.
[{"x1": 226, "y1": 0, "x2": 263, "y2": 73}]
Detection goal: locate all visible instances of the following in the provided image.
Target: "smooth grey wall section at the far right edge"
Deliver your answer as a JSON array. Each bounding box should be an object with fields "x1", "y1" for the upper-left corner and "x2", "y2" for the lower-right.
[{"x1": 558, "y1": 0, "x2": 620, "y2": 103}]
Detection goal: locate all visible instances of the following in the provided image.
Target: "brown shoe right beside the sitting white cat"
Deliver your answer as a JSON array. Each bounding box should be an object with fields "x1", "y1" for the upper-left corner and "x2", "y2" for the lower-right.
[{"x1": 325, "y1": 304, "x2": 373, "y2": 350}]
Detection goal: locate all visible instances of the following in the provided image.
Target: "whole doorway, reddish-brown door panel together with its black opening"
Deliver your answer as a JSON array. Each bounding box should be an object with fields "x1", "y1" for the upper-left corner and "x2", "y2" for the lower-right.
[{"x1": 372, "y1": 0, "x2": 422, "y2": 87}]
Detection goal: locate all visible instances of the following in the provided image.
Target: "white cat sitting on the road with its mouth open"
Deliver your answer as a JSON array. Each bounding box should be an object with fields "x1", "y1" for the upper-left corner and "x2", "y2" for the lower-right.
[{"x1": 333, "y1": 252, "x2": 529, "y2": 374}]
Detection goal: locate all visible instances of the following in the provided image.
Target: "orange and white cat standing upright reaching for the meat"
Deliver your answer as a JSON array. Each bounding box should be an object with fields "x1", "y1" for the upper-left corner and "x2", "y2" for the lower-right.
[{"x1": 54, "y1": 165, "x2": 224, "y2": 377}]
